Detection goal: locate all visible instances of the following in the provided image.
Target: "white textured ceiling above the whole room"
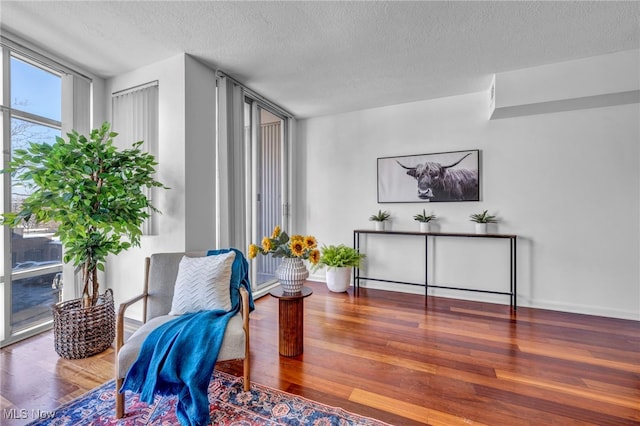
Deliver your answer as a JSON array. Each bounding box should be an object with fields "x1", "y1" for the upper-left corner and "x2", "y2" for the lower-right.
[{"x1": 0, "y1": 0, "x2": 640, "y2": 117}]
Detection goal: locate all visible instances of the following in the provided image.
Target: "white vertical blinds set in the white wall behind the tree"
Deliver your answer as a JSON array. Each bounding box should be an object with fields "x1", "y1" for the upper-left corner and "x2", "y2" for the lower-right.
[{"x1": 112, "y1": 81, "x2": 158, "y2": 235}]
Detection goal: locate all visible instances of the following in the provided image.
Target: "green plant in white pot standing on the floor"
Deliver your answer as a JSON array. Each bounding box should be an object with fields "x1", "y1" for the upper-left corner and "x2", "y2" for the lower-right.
[{"x1": 315, "y1": 244, "x2": 366, "y2": 293}]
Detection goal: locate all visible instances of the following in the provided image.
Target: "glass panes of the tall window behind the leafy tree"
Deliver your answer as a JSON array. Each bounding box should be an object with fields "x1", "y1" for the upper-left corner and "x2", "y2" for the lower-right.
[{"x1": 3, "y1": 53, "x2": 62, "y2": 334}]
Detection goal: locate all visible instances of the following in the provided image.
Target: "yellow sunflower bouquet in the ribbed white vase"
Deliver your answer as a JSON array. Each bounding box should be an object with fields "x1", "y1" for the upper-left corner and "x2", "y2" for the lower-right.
[{"x1": 249, "y1": 226, "x2": 320, "y2": 265}]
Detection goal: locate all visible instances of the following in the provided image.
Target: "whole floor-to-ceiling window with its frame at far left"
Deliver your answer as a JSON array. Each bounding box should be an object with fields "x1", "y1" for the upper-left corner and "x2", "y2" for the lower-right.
[{"x1": 0, "y1": 37, "x2": 91, "y2": 345}]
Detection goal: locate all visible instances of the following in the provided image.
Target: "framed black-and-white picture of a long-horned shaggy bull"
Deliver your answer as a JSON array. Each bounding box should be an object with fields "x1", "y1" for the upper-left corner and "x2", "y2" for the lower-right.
[{"x1": 378, "y1": 149, "x2": 480, "y2": 203}]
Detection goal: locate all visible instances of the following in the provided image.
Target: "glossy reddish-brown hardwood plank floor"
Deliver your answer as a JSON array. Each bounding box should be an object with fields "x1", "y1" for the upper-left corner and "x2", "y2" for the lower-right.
[{"x1": 0, "y1": 283, "x2": 640, "y2": 426}]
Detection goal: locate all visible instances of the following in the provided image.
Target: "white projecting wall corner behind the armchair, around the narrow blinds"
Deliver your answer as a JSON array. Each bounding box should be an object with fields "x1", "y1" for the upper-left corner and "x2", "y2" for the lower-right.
[{"x1": 103, "y1": 54, "x2": 216, "y2": 317}]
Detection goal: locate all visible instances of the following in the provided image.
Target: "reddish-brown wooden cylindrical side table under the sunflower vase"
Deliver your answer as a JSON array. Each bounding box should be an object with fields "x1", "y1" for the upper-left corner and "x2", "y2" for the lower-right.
[{"x1": 269, "y1": 286, "x2": 313, "y2": 356}]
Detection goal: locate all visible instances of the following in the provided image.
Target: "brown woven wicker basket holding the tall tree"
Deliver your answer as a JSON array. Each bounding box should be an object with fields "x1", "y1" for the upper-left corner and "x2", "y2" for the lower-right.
[{"x1": 53, "y1": 289, "x2": 116, "y2": 359}]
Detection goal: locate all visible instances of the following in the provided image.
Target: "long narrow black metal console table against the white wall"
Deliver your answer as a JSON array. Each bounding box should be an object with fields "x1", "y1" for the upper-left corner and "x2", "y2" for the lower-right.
[{"x1": 353, "y1": 229, "x2": 517, "y2": 311}]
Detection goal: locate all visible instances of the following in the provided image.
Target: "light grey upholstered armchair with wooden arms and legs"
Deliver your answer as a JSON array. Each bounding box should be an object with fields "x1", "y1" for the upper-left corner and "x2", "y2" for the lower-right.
[{"x1": 115, "y1": 252, "x2": 251, "y2": 418}]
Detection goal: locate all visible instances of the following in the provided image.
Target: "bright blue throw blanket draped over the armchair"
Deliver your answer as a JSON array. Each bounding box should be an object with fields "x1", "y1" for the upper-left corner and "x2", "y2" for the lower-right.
[{"x1": 120, "y1": 249, "x2": 254, "y2": 425}]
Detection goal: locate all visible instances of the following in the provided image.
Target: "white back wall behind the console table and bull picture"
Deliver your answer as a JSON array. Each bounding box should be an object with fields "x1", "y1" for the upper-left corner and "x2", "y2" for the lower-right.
[{"x1": 294, "y1": 56, "x2": 640, "y2": 320}]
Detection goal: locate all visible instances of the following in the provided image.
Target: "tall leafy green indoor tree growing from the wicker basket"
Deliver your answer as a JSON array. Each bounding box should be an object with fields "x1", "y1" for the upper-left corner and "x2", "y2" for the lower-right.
[{"x1": 0, "y1": 122, "x2": 166, "y2": 307}]
